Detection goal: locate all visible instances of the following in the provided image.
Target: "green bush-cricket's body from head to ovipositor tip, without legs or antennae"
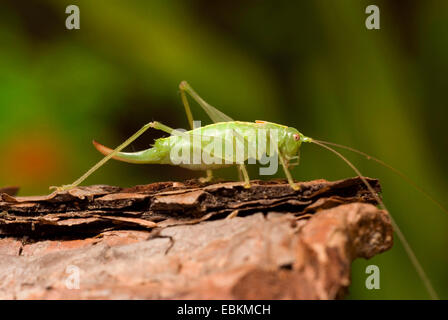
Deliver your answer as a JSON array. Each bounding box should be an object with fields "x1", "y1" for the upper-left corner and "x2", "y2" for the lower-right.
[{"x1": 94, "y1": 121, "x2": 310, "y2": 171}]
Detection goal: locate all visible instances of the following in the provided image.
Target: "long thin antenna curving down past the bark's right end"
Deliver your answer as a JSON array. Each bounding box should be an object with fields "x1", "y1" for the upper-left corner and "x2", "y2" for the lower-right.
[{"x1": 309, "y1": 139, "x2": 439, "y2": 300}]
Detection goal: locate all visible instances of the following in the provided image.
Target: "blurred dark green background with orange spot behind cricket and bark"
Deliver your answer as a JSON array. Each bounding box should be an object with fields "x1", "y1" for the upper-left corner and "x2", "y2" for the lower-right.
[{"x1": 0, "y1": 0, "x2": 448, "y2": 299}]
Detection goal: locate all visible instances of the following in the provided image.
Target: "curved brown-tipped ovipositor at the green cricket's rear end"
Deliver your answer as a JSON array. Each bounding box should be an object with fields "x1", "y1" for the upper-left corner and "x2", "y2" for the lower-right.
[{"x1": 92, "y1": 140, "x2": 163, "y2": 164}]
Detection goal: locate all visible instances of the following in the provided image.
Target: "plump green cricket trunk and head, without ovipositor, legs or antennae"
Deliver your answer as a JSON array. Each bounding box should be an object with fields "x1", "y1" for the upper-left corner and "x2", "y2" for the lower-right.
[{"x1": 159, "y1": 121, "x2": 300, "y2": 170}]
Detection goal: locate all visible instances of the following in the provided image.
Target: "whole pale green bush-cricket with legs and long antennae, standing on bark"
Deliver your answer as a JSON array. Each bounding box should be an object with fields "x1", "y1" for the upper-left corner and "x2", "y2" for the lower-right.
[{"x1": 56, "y1": 81, "x2": 448, "y2": 299}]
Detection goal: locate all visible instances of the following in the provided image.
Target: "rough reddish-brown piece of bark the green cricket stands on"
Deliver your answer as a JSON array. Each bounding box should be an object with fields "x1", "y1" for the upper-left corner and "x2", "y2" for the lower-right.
[{"x1": 0, "y1": 178, "x2": 393, "y2": 299}]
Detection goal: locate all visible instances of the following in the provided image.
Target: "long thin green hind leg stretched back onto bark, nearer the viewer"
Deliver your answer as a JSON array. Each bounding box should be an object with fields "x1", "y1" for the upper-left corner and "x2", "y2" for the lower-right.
[{"x1": 50, "y1": 121, "x2": 174, "y2": 191}]
